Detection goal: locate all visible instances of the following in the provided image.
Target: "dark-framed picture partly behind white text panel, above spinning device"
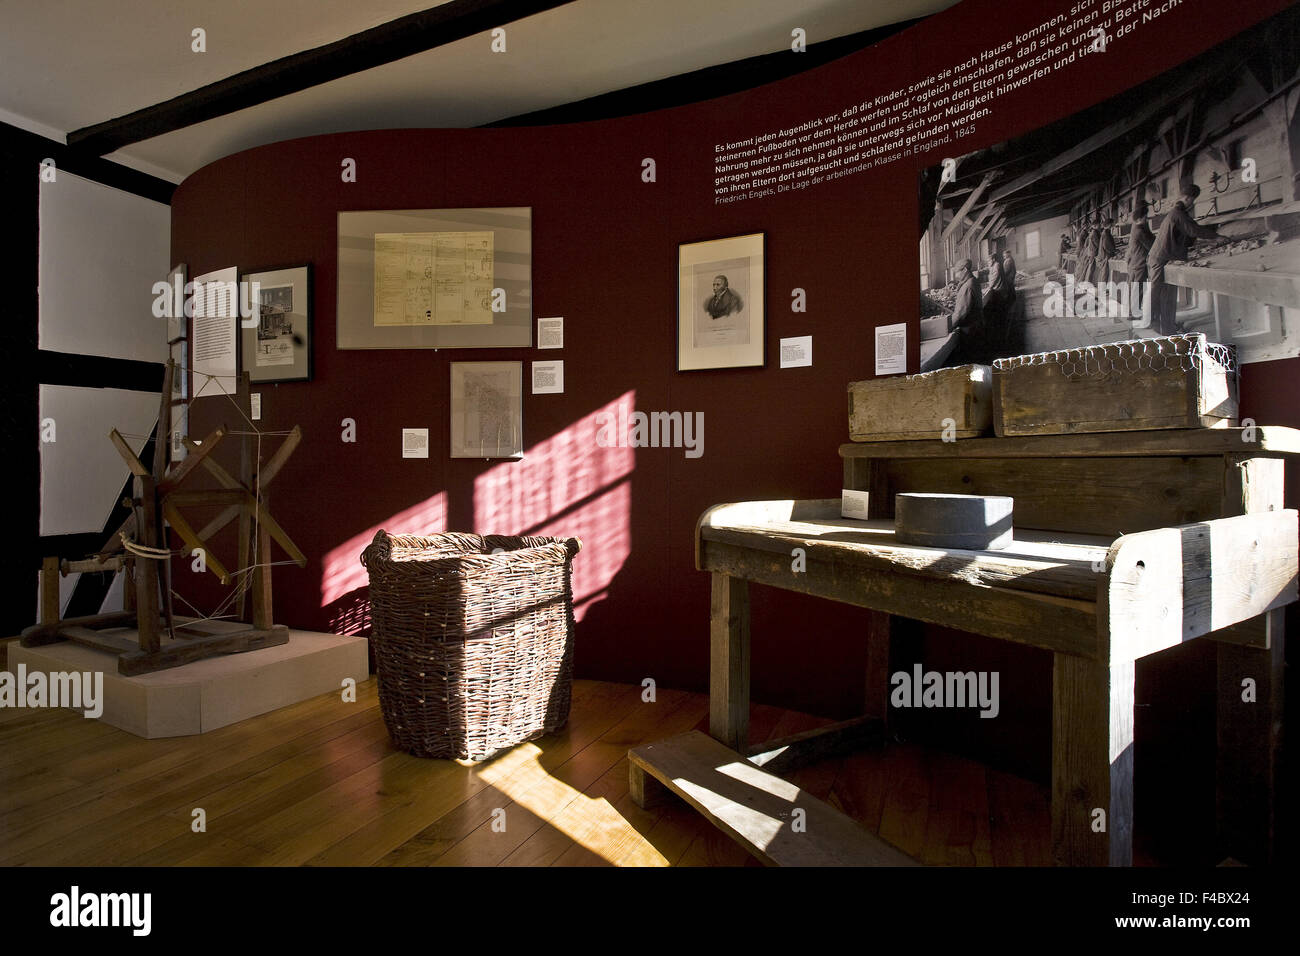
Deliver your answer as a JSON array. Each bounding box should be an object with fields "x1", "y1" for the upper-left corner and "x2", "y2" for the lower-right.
[{"x1": 239, "y1": 265, "x2": 312, "y2": 382}]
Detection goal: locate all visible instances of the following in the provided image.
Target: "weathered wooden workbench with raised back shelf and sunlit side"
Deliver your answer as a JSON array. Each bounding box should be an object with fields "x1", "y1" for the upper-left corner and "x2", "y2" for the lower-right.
[{"x1": 626, "y1": 428, "x2": 1300, "y2": 865}]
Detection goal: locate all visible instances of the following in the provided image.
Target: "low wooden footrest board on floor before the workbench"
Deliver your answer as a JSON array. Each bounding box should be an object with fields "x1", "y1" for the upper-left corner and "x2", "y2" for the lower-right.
[{"x1": 628, "y1": 731, "x2": 919, "y2": 866}]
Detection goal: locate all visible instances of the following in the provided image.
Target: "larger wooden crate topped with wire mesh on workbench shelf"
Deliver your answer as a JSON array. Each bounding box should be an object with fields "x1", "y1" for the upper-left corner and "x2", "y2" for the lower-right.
[{"x1": 993, "y1": 333, "x2": 1238, "y2": 437}]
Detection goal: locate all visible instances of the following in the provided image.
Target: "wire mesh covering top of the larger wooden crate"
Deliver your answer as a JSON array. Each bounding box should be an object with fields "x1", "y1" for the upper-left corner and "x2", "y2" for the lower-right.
[{"x1": 993, "y1": 332, "x2": 1238, "y2": 378}]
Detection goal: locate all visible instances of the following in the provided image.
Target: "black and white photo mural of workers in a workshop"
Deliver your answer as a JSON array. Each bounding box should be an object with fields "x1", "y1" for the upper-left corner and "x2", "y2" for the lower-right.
[{"x1": 919, "y1": 9, "x2": 1300, "y2": 372}]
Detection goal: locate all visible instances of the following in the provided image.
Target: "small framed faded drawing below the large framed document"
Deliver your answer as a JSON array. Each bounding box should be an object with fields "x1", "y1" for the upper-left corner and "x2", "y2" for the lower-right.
[{"x1": 451, "y1": 362, "x2": 524, "y2": 458}]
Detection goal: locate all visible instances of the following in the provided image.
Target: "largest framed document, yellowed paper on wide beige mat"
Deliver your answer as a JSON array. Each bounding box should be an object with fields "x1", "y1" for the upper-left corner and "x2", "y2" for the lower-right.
[{"x1": 337, "y1": 206, "x2": 533, "y2": 349}]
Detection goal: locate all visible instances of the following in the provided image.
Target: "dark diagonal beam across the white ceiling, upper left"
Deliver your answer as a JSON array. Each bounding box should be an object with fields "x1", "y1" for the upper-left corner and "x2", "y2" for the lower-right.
[{"x1": 68, "y1": 0, "x2": 585, "y2": 156}]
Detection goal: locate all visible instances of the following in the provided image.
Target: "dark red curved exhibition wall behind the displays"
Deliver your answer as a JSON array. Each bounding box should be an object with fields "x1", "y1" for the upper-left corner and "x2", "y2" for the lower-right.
[{"x1": 172, "y1": 0, "x2": 1300, "y2": 816}]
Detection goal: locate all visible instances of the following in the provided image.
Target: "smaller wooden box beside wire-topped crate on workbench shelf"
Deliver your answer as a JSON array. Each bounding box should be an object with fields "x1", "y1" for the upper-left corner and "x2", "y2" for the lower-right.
[{"x1": 849, "y1": 365, "x2": 993, "y2": 441}]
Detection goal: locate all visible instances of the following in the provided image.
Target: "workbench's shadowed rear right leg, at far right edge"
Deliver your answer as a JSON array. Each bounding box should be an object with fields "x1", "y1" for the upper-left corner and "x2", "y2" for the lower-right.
[{"x1": 1216, "y1": 609, "x2": 1286, "y2": 865}]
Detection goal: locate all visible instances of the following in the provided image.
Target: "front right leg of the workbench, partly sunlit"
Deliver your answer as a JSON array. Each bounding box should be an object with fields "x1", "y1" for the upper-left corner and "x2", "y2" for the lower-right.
[{"x1": 1052, "y1": 654, "x2": 1134, "y2": 866}]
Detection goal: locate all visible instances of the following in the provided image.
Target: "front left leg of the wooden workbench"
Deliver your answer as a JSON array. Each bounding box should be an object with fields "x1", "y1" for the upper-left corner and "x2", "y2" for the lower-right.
[{"x1": 709, "y1": 571, "x2": 749, "y2": 753}]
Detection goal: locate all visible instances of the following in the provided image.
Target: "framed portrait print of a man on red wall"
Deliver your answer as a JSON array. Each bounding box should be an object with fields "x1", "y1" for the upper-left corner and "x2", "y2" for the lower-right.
[{"x1": 677, "y1": 233, "x2": 764, "y2": 372}]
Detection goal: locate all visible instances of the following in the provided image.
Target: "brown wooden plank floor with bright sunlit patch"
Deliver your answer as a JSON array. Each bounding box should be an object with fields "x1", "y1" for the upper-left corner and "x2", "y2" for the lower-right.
[{"x1": 0, "y1": 658, "x2": 1118, "y2": 866}]
